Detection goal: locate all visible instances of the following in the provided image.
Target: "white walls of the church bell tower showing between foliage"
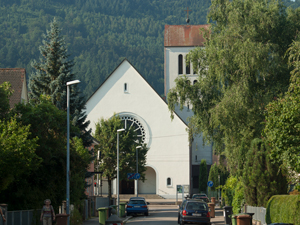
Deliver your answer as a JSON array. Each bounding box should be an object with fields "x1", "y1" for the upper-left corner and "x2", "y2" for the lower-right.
[{"x1": 165, "y1": 47, "x2": 212, "y2": 165}]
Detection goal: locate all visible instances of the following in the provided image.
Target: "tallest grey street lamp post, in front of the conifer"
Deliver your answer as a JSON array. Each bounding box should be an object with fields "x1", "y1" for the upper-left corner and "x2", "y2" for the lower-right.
[{"x1": 66, "y1": 80, "x2": 80, "y2": 225}]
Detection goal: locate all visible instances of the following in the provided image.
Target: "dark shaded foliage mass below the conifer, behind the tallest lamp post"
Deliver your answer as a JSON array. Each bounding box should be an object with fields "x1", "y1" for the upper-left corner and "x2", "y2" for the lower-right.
[{"x1": 2, "y1": 96, "x2": 91, "y2": 210}]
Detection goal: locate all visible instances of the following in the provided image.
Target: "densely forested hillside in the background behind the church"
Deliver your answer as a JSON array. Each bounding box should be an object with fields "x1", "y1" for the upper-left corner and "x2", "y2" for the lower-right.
[{"x1": 0, "y1": 0, "x2": 300, "y2": 98}]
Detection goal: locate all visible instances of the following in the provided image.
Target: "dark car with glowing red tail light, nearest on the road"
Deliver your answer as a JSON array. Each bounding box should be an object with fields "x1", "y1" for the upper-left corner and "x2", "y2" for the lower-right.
[{"x1": 178, "y1": 199, "x2": 211, "y2": 225}]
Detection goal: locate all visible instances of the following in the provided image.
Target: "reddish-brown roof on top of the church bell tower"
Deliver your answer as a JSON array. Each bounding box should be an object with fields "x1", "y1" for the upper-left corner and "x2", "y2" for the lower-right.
[{"x1": 164, "y1": 24, "x2": 209, "y2": 47}]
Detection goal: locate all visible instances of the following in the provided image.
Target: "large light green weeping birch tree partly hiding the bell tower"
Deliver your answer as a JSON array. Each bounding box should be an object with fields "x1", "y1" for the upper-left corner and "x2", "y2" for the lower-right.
[{"x1": 167, "y1": 0, "x2": 300, "y2": 175}]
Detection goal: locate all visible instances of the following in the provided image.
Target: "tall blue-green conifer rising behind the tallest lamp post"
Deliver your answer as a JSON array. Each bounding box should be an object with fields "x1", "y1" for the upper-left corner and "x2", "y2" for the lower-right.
[{"x1": 29, "y1": 18, "x2": 91, "y2": 146}]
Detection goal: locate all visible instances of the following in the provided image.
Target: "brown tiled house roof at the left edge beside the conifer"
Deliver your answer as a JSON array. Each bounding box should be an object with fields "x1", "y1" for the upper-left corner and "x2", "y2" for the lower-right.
[{"x1": 0, "y1": 68, "x2": 26, "y2": 108}]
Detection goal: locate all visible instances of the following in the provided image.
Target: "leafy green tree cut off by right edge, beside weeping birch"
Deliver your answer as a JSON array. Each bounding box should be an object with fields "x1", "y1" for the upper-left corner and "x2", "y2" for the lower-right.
[{"x1": 264, "y1": 37, "x2": 300, "y2": 178}]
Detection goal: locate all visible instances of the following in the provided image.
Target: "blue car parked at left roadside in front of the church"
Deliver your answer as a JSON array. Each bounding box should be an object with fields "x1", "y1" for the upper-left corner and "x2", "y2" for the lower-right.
[{"x1": 126, "y1": 197, "x2": 150, "y2": 216}]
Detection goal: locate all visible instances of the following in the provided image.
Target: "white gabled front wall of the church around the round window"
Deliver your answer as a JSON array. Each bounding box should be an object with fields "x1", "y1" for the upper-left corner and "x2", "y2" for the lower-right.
[{"x1": 86, "y1": 60, "x2": 190, "y2": 198}]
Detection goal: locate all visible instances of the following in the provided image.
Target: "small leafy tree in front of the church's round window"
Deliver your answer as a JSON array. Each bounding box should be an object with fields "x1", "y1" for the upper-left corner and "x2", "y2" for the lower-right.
[{"x1": 94, "y1": 116, "x2": 148, "y2": 200}]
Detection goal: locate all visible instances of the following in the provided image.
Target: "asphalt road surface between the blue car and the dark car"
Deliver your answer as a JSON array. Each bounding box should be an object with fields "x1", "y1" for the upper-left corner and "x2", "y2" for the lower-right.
[{"x1": 126, "y1": 205, "x2": 178, "y2": 225}]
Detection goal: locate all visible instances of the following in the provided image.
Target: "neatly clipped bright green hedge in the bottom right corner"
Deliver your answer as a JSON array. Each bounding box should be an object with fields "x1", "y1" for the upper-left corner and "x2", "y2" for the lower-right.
[{"x1": 266, "y1": 195, "x2": 300, "y2": 225}]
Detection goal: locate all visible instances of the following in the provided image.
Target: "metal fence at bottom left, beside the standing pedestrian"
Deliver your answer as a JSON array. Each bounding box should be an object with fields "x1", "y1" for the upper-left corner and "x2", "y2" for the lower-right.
[{"x1": 0, "y1": 210, "x2": 42, "y2": 225}]
